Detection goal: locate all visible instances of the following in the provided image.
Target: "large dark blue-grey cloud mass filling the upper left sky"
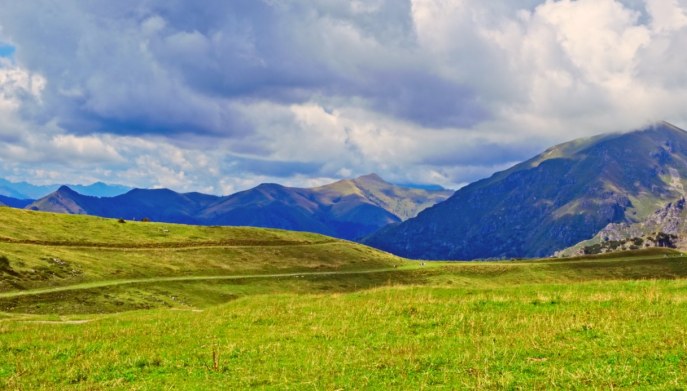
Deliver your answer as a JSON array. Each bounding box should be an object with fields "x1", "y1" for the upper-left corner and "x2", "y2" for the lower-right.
[{"x1": 0, "y1": 0, "x2": 484, "y2": 137}]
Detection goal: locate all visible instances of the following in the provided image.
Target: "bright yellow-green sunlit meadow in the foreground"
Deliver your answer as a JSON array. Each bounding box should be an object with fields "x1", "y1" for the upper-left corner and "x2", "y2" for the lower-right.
[{"x1": 0, "y1": 281, "x2": 687, "y2": 389}]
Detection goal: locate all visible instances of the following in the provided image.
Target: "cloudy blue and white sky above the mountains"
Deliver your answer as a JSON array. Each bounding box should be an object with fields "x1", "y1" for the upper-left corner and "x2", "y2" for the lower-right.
[{"x1": 0, "y1": 0, "x2": 687, "y2": 194}]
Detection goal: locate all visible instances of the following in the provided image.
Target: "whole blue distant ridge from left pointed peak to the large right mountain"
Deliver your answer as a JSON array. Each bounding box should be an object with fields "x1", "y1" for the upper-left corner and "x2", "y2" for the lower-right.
[{"x1": 27, "y1": 174, "x2": 453, "y2": 240}]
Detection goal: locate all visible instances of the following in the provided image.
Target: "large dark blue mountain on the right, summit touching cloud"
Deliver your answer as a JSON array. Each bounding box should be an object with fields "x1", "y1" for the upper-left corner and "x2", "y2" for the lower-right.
[{"x1": 366, "y1": 123, "x2": 687, "y2": 259}]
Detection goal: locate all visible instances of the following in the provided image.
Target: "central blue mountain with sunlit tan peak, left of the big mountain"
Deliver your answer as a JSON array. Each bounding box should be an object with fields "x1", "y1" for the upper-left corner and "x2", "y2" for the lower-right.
[{"x1": 202, "y1": 174, "x2": 452, "y2": 240}]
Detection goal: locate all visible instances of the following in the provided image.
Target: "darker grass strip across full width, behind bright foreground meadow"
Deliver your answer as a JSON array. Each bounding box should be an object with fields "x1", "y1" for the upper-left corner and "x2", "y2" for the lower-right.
[{"x1": 8, "y1": 254, "x2": 687, "y2": 315}]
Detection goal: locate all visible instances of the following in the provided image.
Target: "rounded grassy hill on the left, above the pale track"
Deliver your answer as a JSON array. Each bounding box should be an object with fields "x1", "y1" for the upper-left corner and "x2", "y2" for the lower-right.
[{"x1": 0, "y1": 208, "x2": 403, "y2": 292}]
